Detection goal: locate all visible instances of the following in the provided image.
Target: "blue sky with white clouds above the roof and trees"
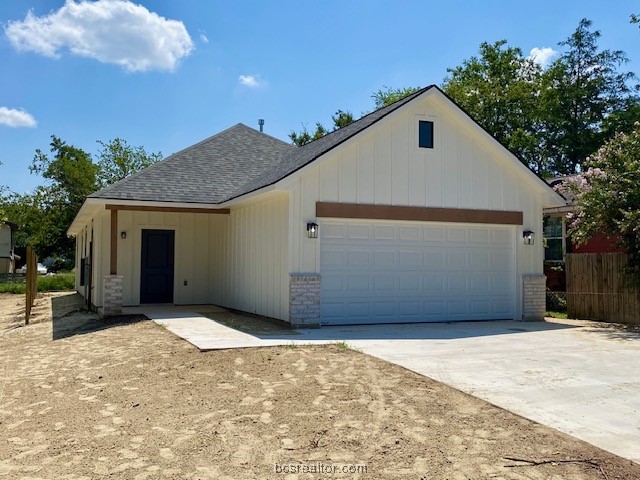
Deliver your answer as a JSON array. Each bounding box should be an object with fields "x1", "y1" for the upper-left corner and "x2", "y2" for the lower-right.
[{"x1": 0, "y1": 0, "x2": 640, "y2": 192}]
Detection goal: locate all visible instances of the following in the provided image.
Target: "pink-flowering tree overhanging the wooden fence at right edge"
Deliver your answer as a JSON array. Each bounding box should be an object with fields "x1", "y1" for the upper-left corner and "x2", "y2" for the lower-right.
[{"x1": 562, "y1": 123, "x2": 640, "y2": 285}]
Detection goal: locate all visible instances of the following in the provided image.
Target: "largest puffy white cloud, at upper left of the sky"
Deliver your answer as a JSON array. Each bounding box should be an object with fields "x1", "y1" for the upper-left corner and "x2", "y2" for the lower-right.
[{"x1": 5, "y1": 0, "x2": 194, "y2": 71}]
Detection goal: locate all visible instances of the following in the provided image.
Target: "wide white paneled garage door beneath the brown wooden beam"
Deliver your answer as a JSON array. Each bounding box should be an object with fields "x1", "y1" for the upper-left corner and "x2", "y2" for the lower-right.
[{"x1": 320, "y1": 220, "x2": 516, "y2": 325}]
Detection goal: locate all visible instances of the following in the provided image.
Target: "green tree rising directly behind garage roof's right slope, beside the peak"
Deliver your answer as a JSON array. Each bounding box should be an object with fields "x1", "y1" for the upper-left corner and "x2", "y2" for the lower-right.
[{"x1": 442, "y1": 40, "x2": 547, "y2": 173}]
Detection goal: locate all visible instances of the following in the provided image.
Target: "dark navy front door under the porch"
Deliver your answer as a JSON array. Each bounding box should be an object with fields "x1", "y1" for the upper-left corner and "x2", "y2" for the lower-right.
[{"x1": 140, "y1": 230, "x2": 174, "y2": 303}]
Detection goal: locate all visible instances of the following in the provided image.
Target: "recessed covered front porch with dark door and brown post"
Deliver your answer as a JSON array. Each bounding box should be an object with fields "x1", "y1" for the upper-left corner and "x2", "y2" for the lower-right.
[{"x1": 69, "y1": 194, "x2": 288, "y2": 320}]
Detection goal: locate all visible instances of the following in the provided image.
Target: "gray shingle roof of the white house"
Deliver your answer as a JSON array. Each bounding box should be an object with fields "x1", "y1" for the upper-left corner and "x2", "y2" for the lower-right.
[{"x1": 89, "y1": 86, "x2": 434, "y2": 204}]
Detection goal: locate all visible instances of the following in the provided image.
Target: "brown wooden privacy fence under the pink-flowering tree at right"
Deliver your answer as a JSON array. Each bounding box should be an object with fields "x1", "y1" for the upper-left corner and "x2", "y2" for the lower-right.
[{"x1": 565, "y1": 253, "x2": 640, "y2": 324}]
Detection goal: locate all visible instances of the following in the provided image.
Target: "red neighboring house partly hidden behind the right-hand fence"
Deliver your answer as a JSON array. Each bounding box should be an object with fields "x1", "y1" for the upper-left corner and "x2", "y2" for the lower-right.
[{"x1": 543, "y1": 175, "x2": 624, "y2": 290}]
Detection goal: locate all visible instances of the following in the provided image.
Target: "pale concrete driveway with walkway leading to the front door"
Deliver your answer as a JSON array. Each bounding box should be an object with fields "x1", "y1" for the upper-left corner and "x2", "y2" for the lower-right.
[{"x1": 138, "y1": 307, "x2": 640, "y2": 463}]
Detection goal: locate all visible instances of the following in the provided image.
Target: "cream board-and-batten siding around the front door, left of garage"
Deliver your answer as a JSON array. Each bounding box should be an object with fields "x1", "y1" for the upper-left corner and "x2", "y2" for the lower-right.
[{"x1": 84, "y1": 192, "x2": 289, "y2": 319}]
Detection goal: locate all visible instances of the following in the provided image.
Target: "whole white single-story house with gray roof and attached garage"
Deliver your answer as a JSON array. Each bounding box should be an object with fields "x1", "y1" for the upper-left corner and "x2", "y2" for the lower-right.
[{"x1": 68, "y1": 86, "x2": 564, "y2": 326}]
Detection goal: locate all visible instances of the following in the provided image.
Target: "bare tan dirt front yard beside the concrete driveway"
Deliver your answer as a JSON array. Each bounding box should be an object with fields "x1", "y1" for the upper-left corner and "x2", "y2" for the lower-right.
[{"x1": 0, "y1": 295, "x2": 640, "y2": 480}]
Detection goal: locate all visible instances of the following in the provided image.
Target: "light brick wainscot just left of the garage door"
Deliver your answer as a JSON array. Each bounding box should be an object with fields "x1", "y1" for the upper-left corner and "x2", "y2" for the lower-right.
[{"x1": 289, "y1": 273, "x2": 320, "y2": 328}]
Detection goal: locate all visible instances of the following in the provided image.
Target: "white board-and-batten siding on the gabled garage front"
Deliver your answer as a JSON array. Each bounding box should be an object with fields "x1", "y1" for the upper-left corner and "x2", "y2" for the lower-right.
[{"x1": 287, "y1": 90, "x2": 543, "y2": 318}]
